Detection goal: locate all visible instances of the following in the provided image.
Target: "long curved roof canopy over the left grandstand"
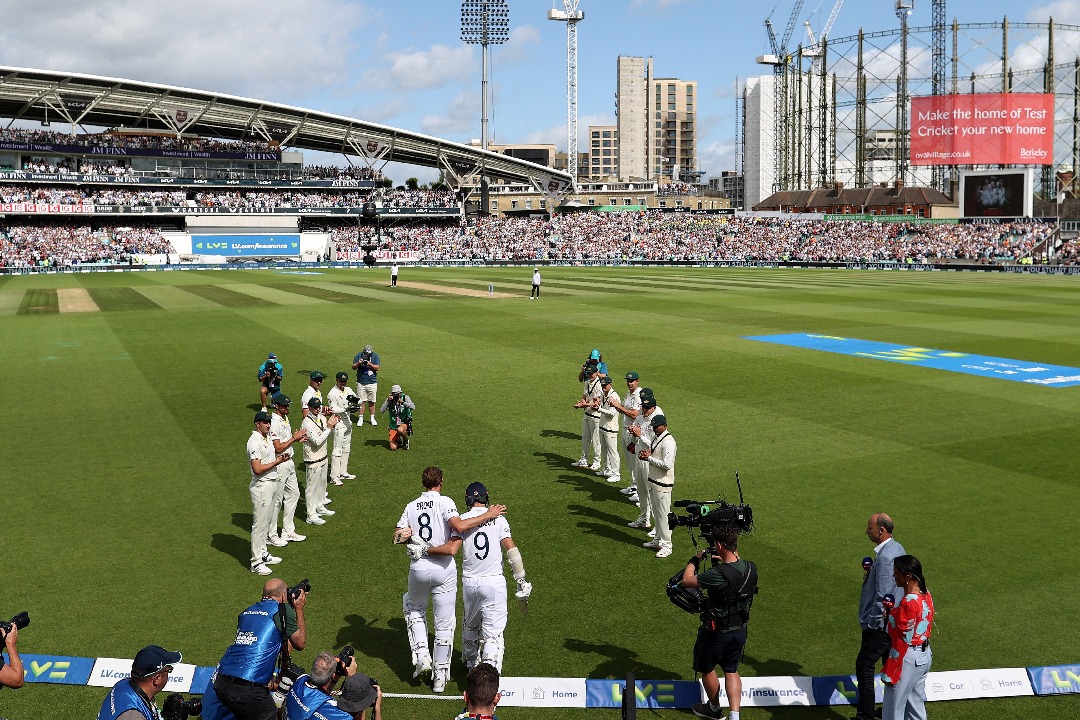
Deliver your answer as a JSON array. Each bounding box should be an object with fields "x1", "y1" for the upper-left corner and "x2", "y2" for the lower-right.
[{"x1": 0, "y1": 66, "x2": 570, "y2": 186}]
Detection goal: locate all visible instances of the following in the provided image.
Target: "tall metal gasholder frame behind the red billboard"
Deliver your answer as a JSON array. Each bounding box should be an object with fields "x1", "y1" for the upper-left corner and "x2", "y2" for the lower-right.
[{"x1": 742, "y1": 18, "x2": 1080, "y2": 202}]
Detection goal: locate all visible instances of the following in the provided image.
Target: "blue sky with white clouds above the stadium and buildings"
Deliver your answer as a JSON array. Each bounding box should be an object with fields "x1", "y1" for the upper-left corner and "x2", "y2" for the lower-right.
[{"x1": 0, "y1": 0, "x2": 1080, "y2": 182}]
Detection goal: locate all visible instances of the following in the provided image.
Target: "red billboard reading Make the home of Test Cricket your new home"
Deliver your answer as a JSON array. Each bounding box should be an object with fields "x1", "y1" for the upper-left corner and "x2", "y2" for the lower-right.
[{"x1": 910, "y1": 93, "x2": 1054, "y2": 165}]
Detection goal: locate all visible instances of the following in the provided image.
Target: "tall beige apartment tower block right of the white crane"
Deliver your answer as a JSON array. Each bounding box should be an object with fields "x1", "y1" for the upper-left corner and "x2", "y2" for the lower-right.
[{"x1": 617, "y1": 55, "x2": 700, "y2": 182}]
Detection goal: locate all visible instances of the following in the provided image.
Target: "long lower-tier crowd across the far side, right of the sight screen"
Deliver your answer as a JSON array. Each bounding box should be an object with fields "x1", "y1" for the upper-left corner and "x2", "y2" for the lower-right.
[{"x1": 332, "y1": 210, "x2": 1053, "y2": 262}]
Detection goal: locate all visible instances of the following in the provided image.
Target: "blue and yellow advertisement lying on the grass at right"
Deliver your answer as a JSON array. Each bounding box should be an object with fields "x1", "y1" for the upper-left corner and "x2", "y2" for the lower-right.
[{"x1": 744, "y1": 332, "x2": 1080, "y2": 388}]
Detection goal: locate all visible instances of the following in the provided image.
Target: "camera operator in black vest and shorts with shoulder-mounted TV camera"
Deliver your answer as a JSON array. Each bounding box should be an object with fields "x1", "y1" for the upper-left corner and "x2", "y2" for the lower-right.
[{"x1": 681, "y1": 524, "x2": 757, "y2": 720}]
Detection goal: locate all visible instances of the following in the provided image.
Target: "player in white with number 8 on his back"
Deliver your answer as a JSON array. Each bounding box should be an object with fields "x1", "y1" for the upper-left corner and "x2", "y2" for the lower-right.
[{"x1": 393, "y1": 467, "x2": 507, "y2": 693}]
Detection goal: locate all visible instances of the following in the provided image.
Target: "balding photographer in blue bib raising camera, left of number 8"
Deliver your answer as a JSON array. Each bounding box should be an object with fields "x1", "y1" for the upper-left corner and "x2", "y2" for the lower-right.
[{"x1": 213, "y1": 578, "x2": 308, "y2": 720}]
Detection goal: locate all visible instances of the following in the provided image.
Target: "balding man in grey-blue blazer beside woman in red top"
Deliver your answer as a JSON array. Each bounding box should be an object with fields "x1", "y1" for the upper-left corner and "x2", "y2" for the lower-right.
[{"x1": 854, "y1": 513, "x2": 905, "y2": 720}]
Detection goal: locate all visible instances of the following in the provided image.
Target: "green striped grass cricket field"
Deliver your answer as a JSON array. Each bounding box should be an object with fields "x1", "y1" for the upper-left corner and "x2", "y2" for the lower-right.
[{"x1": 0, "y1": 268, "x2": 1080, "y2": 720}]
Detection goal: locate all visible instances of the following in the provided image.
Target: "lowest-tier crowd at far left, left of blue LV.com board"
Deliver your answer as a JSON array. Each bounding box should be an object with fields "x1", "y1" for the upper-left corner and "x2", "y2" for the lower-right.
[{"x1": 0, "y1": 222, "x2": 174, "y2": 268}]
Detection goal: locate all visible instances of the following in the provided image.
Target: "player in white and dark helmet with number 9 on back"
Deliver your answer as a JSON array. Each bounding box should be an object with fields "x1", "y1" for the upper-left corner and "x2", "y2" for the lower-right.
[{"x1": 426, "y1": 483, "x2": 532, "y2": 673}]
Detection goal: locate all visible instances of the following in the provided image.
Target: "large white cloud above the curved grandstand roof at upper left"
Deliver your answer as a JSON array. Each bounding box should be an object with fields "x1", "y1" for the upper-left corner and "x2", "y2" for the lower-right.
[{"x1": 0, "y1": 0, "x2": 366, "y2": 98}]
